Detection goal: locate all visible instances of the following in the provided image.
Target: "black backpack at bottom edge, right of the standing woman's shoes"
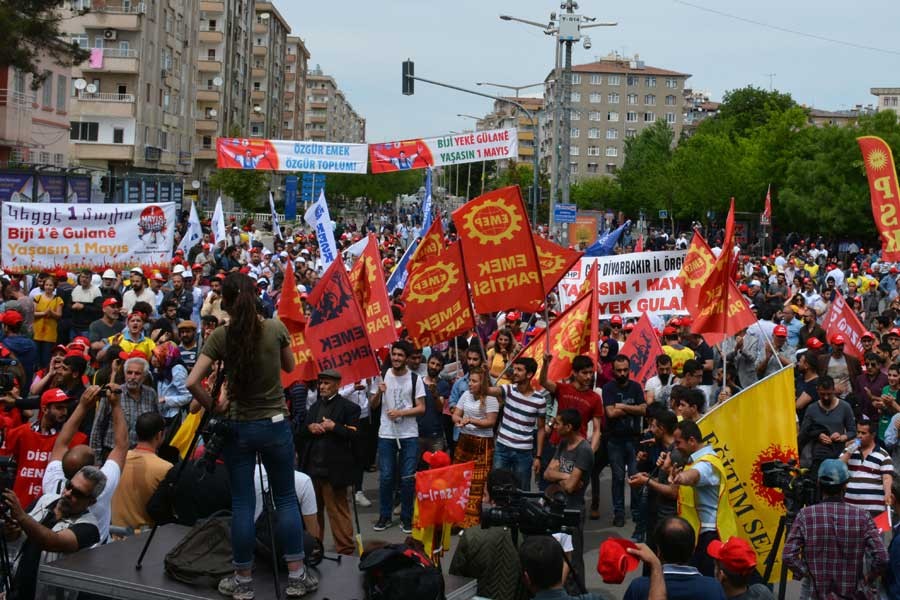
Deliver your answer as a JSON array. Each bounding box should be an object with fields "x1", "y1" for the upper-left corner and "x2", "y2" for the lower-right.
[{"x1": 359, "y1": 544, "x2": 444, "y2": 600}]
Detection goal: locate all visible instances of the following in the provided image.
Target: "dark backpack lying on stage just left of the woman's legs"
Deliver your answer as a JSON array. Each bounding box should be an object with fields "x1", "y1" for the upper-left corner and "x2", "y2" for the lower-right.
[{"x1": 165, "y1": 511, "x2": 234, "y2": 587}]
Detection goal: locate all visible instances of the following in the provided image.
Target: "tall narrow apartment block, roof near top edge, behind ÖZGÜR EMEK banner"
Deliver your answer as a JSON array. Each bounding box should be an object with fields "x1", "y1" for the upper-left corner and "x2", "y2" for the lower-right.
[{"x1": 250, "y1": 2, "x2": 291, "y2": 140}]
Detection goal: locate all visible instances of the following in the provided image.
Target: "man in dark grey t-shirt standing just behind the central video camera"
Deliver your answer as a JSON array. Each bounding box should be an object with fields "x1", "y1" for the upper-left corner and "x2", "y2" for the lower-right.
[{"x1": 544, "y1": 408, "x2": 594, "y2": 589}]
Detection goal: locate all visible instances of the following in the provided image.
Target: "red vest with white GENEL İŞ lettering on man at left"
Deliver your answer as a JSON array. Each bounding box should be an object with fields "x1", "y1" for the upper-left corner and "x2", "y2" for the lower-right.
[{"x1": 0, "y1": 423, "x2": 88, "y2": 507}]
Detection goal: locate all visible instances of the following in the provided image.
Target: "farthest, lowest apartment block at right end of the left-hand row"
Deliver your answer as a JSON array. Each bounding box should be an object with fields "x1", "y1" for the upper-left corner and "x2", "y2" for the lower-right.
[{"x1": 305, "y1": 65, "x2": 366, "y2": 143}]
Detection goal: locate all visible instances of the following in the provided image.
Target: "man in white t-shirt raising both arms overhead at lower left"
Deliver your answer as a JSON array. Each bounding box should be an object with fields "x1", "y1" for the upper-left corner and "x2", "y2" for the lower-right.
[{"x1": 41, "y1": 384, "x2": 129, "y2": 544}]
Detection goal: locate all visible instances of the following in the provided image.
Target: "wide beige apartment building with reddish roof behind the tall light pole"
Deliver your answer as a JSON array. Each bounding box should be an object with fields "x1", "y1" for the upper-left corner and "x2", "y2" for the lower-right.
[{"x1": 542, "y1": 54, "x2": 690, "y2": 181}]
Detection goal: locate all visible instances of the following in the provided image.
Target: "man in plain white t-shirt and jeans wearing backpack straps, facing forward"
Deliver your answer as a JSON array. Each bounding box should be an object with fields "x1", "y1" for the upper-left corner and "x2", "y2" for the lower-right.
[{"x1": 369, "y1": 340, "x2": 425, "y2": 533}]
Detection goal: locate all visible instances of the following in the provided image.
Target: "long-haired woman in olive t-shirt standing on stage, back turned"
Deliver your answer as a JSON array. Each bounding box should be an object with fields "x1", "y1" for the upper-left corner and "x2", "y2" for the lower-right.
[{"x1": 187, "y1": 273, "x2": 319, "y2": 600}]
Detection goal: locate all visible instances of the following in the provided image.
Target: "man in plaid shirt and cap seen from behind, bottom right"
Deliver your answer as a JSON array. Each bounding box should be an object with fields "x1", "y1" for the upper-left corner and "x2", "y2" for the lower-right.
[{"x1": 782, "y1": 458, "x2": 888, "y2": 598}]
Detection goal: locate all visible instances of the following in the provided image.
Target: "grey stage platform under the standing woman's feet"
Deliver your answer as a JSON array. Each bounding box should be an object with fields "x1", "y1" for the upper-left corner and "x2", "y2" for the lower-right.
[{"x1": 38, "y1": 525, "x2": 476, "y2": 600}]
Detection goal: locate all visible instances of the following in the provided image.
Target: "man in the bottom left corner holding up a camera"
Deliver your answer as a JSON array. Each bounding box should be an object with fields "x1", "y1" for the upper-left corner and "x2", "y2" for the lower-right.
[{"x1": 3, "y1": 467, "x2": 106, "y2": 600}]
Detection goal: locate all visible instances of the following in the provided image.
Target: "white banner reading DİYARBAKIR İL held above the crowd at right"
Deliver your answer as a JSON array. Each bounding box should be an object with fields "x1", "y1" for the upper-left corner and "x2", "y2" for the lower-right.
[{"x1": 559, "y1": 250, "x2": 688, "y2": 319}]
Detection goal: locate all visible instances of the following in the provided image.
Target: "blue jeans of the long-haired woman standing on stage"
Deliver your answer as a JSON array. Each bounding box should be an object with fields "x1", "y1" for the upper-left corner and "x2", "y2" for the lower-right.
[{"x1": 223, "y1": 419, "x2": 303, "y2": 569}]
